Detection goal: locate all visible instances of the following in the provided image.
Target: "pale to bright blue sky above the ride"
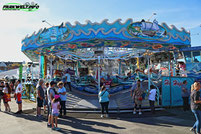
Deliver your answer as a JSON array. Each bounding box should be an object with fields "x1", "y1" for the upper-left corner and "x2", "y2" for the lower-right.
[{"x1": 0, "y1": 0, "x2": 201, "y2": 62}]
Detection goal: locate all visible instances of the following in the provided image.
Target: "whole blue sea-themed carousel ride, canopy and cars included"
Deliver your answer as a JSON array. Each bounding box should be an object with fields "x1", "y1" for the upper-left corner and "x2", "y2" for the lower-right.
[{"x1": 22, "y1": 19, "x2": 190, "y2": 107}]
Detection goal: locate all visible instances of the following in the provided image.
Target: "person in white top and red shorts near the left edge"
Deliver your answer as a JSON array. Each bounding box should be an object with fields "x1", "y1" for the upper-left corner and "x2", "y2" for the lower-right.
[{"x1": 15, "y1": 80, "x2": 23, "y2": 114}]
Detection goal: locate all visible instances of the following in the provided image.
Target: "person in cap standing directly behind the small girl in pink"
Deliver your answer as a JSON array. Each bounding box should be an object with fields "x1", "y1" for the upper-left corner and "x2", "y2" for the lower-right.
[{"x1": 47, "y1": 81, "x2": 57, "y2": 127}]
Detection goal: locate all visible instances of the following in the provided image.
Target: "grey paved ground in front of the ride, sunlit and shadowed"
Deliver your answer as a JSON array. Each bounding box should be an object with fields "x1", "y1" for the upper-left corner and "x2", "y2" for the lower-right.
[{"x1": 0, "y1": 100, "x2": 194, "y2": 134}]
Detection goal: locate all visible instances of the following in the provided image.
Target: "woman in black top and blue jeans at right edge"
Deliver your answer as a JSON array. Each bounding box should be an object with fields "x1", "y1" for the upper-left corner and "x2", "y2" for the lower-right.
[{"x1": 190, "y1": 82, "x2": 201, "y2": 134}]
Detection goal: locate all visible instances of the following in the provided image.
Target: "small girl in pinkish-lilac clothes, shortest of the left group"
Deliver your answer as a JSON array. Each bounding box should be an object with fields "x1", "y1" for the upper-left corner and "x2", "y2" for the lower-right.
[{"x1": 51, "y1": 95, "x2": 60, "y2": 130}]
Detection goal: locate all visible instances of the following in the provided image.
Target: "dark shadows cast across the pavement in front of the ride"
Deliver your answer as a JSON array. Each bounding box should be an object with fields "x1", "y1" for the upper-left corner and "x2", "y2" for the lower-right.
[{"x1": 2, "y1": 109, "x2": 194, "y2": 134}]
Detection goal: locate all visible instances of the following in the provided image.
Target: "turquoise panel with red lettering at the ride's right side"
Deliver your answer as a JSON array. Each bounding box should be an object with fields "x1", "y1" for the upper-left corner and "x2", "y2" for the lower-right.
[{"x1": 162, "y1": 77, "x2": 195, "y2": 106}]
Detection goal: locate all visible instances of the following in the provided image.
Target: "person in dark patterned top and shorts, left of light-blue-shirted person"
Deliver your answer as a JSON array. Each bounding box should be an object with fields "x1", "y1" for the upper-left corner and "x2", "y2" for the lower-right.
[{"x1": 133, "y1": 83, "x2": 143, "y2": 115}]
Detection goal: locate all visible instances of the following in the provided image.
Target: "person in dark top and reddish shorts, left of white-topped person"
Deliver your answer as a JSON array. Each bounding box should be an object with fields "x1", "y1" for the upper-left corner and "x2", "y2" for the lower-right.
[{"x1": 3, "y1": 83, "x2": 11, "y2": 112}]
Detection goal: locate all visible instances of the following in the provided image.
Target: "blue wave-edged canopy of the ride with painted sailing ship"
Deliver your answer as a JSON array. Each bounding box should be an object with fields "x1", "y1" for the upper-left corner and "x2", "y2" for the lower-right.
[{"x1": 21, "y1": 19, "x2": 191, "y2": 61}]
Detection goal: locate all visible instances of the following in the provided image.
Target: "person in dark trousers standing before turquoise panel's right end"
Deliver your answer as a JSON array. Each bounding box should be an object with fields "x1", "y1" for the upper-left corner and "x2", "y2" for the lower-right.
[{"x1": 181, "y1": 80, "x2": 190, "y2": 111}]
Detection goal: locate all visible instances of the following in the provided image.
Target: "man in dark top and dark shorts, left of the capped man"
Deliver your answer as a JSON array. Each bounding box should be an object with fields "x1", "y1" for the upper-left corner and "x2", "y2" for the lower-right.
[{"x1": 36, "y1": 79, "x2": 45, "y2": 117}]
